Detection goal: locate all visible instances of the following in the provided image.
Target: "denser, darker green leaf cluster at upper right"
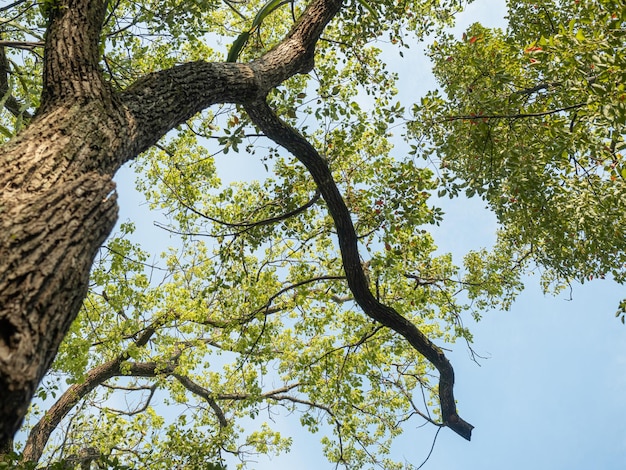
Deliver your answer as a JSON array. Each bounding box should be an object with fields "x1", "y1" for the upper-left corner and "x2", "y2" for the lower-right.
[{"x1": 413, "y1": 1, "x2": 626, "y2": 289}]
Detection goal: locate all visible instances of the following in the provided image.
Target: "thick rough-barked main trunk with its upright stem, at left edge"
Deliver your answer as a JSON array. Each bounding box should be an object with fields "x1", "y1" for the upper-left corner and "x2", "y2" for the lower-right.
[{"x1": 0, "y1": 0, "x2": 117, "y2": 448}]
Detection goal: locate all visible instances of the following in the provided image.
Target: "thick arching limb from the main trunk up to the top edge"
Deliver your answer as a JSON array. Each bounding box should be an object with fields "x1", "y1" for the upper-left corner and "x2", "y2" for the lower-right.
[{"x1": 119, "y1": 0, "x2": 343, "y2": 163}]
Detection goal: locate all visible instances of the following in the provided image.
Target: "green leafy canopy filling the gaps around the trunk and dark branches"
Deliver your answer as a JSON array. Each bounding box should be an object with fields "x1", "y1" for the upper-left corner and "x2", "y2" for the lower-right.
[{"x1": 0, "y1": 0, "x2": 626, "y2": 469}]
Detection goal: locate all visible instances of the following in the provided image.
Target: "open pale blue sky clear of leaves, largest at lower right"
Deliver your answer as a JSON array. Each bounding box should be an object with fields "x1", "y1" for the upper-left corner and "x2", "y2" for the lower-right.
[{"x1": 112, "y1": 0, "x2": 626, "y2": 470}]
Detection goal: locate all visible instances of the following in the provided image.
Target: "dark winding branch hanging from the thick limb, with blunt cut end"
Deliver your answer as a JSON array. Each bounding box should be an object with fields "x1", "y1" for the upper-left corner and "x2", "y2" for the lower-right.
[{"x1": 245, "y1": 100, "x2": 473, "y2": 440}]
